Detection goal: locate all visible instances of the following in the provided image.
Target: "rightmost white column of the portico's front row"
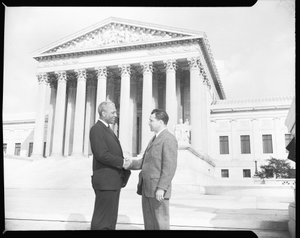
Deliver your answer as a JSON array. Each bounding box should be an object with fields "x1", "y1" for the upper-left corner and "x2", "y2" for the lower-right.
[{"x1": 188, "y1": 58, "x2": 208, "y2": 153}]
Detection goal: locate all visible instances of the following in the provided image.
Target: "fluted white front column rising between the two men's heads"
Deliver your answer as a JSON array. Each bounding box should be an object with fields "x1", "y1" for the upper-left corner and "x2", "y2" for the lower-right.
[{"x1": 119, "y1": 64, "x2": 132, "y2": 157}]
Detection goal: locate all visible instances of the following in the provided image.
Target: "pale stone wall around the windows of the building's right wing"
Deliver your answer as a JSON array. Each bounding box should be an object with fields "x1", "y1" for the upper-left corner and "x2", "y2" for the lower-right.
[{"x1": 210, "y1": 108, "x2": 295, "y2": 184}]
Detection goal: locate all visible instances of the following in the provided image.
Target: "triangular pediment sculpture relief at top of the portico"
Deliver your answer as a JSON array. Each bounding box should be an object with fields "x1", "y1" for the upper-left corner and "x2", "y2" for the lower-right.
[{"x1": 45, "y1": 23, "x2": 187, "y2": 53}]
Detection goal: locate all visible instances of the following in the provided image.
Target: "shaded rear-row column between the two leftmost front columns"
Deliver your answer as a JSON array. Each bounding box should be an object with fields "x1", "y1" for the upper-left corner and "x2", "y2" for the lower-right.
[{"x1": 46, "y1": 77, "x2": 57, "y2": 157}]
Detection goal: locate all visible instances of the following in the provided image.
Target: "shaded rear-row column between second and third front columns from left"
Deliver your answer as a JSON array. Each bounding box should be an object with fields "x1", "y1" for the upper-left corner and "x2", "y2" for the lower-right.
[{"x1": 64, "y1": 78, "x2": 76, "y2": 156}]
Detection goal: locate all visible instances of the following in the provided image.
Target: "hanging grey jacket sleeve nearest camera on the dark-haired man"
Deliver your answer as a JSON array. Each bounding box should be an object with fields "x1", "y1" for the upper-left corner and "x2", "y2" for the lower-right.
[{"x1": 157, "y1": 136, "x2": 178, "y2": 190}]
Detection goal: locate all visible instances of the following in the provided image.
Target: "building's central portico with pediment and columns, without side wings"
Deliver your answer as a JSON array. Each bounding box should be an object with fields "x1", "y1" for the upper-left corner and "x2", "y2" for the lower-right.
[{"x1": 28, "y1": 18, "x2": 225, "y2": 157}]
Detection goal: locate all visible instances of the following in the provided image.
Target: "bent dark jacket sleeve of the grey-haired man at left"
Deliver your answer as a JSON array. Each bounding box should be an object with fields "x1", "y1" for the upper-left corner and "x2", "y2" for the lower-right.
[{"x1": 90, "y1": 127, "x2": 123, "y2": 169}]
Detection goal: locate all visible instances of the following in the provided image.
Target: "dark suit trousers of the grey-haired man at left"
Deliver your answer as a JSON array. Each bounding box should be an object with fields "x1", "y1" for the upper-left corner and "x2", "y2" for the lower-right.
[{"x1": 91, "y1": 189, "x2": 120, "y2": 230}]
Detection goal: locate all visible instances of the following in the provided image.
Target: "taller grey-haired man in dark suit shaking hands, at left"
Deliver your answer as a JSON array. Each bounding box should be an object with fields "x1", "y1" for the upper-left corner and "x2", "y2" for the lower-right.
[{"x1": 90, "y1": 102, "x2": 130, "y2": 230}]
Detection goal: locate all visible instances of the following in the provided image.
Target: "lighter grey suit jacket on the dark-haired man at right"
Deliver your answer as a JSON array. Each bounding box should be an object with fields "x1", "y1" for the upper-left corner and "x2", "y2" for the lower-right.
[{"x1": 130, "y1": 129, "x2": 178, "y2": 198}]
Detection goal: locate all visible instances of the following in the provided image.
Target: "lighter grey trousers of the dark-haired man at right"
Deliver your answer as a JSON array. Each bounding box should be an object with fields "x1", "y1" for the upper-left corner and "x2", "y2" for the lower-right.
[{"x1": 142, "y1": 191, "x2": 170, "y2": 230}]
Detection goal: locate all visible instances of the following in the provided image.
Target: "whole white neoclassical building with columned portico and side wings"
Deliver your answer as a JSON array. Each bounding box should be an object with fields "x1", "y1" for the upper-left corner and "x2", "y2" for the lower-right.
[{"x1": 3, "y1": 18, "x2": 294, "y2": 184}]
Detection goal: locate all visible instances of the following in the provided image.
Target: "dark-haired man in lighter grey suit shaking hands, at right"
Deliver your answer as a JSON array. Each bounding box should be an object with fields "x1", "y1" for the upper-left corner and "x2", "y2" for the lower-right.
[{"x1": 124, "y1": 109, "x2": 178, "y2": 230}]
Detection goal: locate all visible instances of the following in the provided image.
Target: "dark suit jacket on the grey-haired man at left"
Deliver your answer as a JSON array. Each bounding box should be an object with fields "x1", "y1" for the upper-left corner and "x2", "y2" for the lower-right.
[{"x1": 90, "y1": 120, "x2": 130, "y2": 190}]
